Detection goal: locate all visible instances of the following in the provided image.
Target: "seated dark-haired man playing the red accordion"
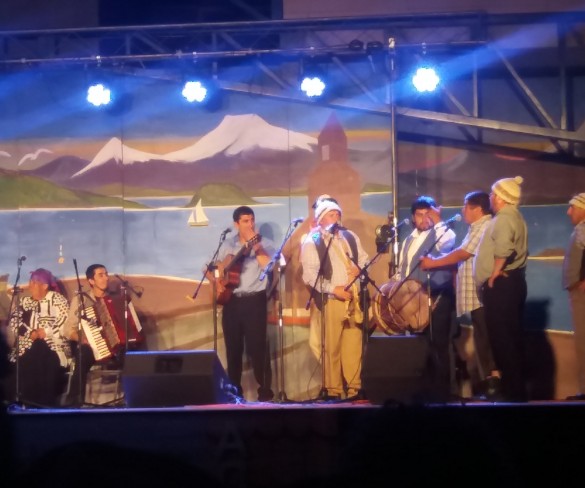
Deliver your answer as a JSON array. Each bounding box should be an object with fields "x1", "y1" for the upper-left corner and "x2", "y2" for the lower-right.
[{"x1": 65, "y1": 263, "x2": 138, "y2": 404}]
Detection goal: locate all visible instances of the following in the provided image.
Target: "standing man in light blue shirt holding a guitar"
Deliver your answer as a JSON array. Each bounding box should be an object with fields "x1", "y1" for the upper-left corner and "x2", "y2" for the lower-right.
[{"x1": 209, "y1": 206, "x2": 275, "y2": 402}]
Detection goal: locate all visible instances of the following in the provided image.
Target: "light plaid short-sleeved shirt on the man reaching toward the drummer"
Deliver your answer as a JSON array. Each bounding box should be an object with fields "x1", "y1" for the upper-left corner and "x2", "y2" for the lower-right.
[{"x1": 457, "y1": 215, "x2": 492, "y2": 317}]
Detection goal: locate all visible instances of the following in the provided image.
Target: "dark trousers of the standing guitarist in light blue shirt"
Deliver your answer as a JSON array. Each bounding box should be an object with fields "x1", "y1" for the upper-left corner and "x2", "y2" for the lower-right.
[{"x1": 221, "y1": 292, "x2": 273, "y2": 399}]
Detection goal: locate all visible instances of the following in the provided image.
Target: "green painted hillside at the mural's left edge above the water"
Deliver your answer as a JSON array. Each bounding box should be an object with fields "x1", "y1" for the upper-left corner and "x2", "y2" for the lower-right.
[{"x1": 0, "y1": 170, "x2": 148, "y2": 209}]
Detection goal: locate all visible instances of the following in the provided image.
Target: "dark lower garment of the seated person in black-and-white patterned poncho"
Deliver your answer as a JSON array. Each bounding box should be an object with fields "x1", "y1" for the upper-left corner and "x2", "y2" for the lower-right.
[{"x1": 8, "y1": 339, "x2": 67, "y2": 407}]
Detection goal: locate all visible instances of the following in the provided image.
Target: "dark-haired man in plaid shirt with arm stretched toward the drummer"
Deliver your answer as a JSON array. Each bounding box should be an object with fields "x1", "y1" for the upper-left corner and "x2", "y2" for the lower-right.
[{"x1": 421, "y1": 191, "x2": 496, "y2": 393}]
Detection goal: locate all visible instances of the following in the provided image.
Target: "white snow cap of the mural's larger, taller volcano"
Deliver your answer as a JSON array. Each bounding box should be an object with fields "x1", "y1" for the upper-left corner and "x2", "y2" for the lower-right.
[{"x1": 163, "y1": 114, "x2": 317, "y2": 162}]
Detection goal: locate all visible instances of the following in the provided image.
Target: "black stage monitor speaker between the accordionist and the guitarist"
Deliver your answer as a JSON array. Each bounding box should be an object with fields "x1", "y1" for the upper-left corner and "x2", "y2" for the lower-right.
[{"x1": 122, "y1": 351, "x2": 232, "y2": 408}]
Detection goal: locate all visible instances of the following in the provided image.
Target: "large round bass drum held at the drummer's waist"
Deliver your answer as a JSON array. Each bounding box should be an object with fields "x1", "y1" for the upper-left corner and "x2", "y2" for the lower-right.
[{"x1": 372, "y1": 280, "x2": 429, "y2": 335}]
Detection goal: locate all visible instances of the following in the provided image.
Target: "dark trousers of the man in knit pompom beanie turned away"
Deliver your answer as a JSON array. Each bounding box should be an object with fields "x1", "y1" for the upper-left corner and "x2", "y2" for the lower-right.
[{"x1": 482, "y1": 268, "x2": 527, "y2": 401}]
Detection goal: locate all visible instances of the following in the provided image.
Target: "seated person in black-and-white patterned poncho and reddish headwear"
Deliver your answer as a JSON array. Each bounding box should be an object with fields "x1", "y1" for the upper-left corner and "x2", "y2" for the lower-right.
[{"x1": 8, "y1": 268, "x2": 71, "y2": 407}]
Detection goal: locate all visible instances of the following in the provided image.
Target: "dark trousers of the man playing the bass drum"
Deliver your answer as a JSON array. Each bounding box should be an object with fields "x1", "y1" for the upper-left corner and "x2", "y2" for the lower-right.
[{"x1": 425, "y1": 288, "x2": 455, "y2": 400}]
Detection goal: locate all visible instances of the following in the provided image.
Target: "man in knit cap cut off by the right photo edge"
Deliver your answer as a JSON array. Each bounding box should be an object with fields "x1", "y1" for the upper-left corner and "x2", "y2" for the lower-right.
[{"x1": 563, "y1": 193, "x2": 585, "y2": 400}]
